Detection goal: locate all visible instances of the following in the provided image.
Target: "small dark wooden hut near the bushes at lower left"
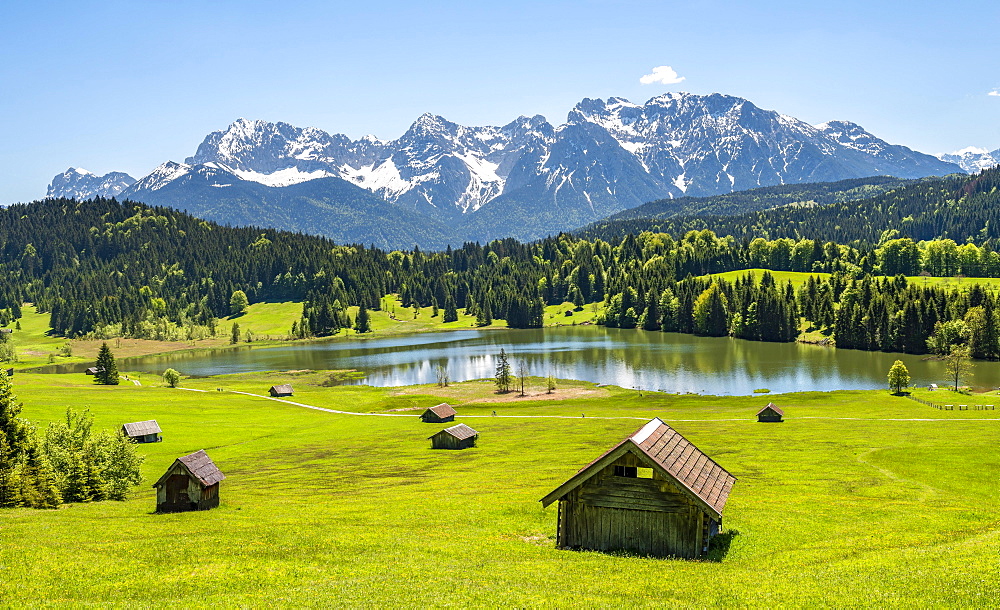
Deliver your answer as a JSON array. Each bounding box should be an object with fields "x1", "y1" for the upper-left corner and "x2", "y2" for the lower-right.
[{"x1": 153, "y1": 449, "x2": 226, "y2": 513}]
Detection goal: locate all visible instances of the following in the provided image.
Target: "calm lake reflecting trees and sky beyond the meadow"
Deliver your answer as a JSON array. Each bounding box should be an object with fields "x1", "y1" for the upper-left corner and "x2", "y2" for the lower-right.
[{"x1": 35, "y1": 326, "x2": 1000, "y2": 395}]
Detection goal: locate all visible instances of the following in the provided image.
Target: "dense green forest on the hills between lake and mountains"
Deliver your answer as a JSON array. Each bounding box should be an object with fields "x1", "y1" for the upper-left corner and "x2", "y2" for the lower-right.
[{"x1": 0, "y1": 169, "x2": 1000, "y2": 358}]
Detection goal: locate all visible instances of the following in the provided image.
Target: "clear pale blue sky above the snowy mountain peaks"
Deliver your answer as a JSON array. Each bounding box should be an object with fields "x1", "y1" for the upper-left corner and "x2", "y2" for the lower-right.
[{"x1": 0, "y1": 0, "x2": 1000, "y2": 204}]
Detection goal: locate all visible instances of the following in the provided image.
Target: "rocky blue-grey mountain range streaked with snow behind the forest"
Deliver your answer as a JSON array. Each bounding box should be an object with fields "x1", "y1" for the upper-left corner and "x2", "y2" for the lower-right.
[{"x1": 49, "y1": 93, "x2": 976, "y2": 239}]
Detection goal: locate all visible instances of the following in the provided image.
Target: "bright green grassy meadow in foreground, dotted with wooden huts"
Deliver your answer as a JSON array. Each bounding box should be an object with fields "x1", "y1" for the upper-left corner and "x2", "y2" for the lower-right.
[{"x1": 0, "y1": 372, "x2": 1000, "y2": 607}]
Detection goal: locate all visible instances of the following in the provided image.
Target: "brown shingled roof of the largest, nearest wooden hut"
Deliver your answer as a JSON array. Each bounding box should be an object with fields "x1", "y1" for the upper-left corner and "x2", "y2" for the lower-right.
[{"x1": 542, "y1": 418, "x2": 736, "y2": 515}]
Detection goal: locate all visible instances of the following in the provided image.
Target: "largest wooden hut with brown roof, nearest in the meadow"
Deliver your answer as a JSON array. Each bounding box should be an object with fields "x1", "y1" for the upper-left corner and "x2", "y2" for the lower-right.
[{"x1": 542, "y1": 418, "x2": 736, "y2": 558}]
